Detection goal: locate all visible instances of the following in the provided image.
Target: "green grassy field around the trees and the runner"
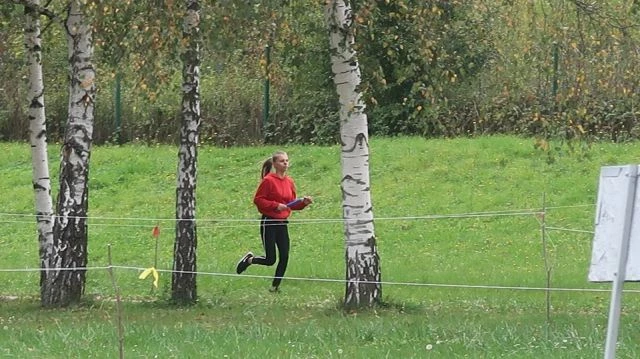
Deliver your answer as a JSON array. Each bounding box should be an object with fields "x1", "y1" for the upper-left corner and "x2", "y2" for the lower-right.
[{"x1": 0, "y1": 137, "x2": 640, "y2": 358}]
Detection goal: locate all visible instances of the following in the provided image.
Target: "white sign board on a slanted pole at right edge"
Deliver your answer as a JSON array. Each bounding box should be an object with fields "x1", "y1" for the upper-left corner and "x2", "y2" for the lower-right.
[{"x1": 589, "y1": 165, "x2": 640, "y2": 282}]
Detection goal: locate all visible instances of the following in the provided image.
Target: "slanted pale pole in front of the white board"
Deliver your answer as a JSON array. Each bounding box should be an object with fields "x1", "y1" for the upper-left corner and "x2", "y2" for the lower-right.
[{"x1": 604, "y1": 165, "x2": 638, "y2": 359}]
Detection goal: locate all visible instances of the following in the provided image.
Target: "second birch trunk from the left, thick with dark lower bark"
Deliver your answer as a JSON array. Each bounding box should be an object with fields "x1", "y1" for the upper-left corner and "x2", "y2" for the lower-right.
[{"x1": 42, "y1": 0, "x2": 96, "y2": 306}]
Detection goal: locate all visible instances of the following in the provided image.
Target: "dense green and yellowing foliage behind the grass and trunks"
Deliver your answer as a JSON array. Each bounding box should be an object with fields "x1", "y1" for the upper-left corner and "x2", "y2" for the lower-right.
[{"x1": 0, "y1": 0, "x2": 640, "y2": 147}]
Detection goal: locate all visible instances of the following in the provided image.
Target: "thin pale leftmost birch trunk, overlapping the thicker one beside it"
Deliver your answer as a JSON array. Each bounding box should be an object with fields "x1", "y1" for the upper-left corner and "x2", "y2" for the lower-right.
[{"x1": 24, "y1": 0, "x2": 59, "y2": 304}]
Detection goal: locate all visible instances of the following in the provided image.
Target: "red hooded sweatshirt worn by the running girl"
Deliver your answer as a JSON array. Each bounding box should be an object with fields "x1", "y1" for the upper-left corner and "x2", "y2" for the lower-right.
[{"x1": 253, "y1": 173, "x2": 306, "y2": 219}]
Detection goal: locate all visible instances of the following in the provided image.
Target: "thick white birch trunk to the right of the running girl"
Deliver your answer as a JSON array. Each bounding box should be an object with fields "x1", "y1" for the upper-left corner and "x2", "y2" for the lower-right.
[{"x1": 325, "y1": 0, "x2": 382, "y2": 308}]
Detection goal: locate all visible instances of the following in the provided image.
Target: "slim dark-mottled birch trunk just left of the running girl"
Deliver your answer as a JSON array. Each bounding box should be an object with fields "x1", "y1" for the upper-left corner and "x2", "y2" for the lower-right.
[{"x1": 171, "y1": 0, "x2": 200, "y2": 304}]
